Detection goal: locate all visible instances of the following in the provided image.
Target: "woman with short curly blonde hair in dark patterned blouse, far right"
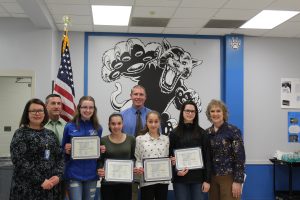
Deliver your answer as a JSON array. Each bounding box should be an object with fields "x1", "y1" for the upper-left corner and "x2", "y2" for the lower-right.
[{"x1": 206, "y1": 100, "x2": 245, "y2": 200}]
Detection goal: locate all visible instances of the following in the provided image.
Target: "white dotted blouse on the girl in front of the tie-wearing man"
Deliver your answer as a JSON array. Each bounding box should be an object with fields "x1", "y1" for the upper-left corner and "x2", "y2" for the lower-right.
[{"x1": 135, "y1": 133, "x2": 170, "y2": 187}]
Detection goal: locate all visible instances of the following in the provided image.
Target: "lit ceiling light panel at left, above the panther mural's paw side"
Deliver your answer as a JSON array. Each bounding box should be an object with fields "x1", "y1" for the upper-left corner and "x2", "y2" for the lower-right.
[{"x1": 92, "y1": 5, "x2": 131, "y2": 26}]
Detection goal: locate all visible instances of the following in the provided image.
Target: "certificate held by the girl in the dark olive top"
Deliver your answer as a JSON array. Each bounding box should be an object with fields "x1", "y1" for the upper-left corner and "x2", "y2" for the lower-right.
[{"x1": 104, "y1": 159, "x2": 133, "y2": 183}]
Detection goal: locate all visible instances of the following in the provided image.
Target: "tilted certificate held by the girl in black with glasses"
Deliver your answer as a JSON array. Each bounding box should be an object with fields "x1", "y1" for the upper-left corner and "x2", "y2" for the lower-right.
[{"x1": 174, "y1": 147, "x2": 203, "y2": 170}]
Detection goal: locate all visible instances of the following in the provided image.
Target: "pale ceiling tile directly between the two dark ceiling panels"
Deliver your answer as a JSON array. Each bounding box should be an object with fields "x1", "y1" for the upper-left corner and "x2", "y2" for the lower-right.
[{"x1": 167, "y1": 18, "x2": 208, "y2": 28}]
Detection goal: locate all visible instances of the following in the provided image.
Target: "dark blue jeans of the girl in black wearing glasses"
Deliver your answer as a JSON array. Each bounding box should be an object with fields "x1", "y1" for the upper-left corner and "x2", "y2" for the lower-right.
[{"x1": 173, "y1": 183, "x2": 204, "y2": 200}]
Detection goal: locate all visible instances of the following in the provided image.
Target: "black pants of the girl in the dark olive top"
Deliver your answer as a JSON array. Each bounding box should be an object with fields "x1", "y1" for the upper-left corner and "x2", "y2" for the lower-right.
[{"x1": 101, "y1": 183, "x2": 132, "y2": 200}]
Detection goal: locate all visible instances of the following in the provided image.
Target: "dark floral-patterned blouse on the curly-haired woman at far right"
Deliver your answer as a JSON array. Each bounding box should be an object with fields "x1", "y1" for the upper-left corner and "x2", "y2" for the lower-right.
[{"x1": 208, "y1": 122, "x2": 246, "y2": 183}]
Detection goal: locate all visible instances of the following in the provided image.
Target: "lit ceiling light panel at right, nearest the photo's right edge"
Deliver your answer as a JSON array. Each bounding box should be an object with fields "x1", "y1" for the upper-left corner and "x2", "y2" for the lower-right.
[{"x1": 240, "y1": 10, "x2": 299, "y2": 29}]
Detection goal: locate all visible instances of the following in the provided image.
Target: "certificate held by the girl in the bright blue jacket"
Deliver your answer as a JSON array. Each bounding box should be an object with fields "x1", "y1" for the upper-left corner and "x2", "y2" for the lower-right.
[{"x1": 71, "y1": 136, "x2": 100, "y2": 160}]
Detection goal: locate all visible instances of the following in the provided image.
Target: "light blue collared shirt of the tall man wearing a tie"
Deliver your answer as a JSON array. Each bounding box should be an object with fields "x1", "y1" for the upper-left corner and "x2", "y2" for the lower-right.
[{"x1": 121, "y1": 106, "x2": 151, "y2": 136}]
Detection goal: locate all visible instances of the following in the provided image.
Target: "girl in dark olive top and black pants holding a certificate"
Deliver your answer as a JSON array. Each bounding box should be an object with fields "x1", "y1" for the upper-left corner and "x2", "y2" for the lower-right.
[{"x1": 98, "y1": 113, "x2": 135, "y2": 200}]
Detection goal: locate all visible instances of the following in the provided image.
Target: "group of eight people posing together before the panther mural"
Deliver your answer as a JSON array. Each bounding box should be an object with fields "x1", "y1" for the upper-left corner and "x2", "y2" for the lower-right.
[{"x1": 10, "y1": 85, "x2": 245, "y2": 200}]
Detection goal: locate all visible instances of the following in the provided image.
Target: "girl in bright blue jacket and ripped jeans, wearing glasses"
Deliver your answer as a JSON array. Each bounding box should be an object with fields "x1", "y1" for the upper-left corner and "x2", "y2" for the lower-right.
[{"x1": 62, "y1": 96, "x2": 104, "y2": 200}]
